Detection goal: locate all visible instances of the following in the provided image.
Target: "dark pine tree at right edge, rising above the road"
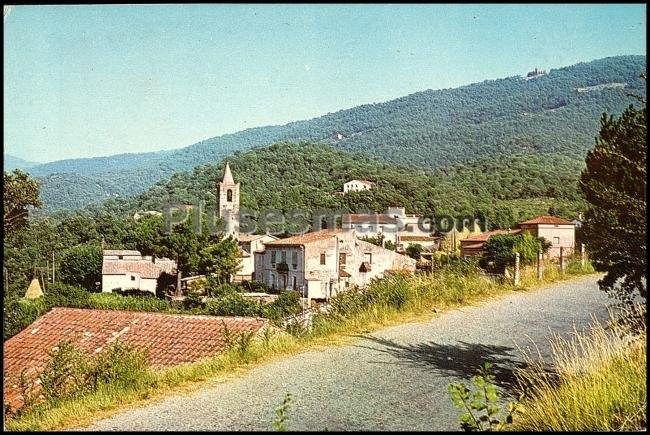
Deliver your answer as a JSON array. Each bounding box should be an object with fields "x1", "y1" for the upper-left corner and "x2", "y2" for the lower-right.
[{"x1": 580, "y1": 101, "x2": 647, "y2": 302}]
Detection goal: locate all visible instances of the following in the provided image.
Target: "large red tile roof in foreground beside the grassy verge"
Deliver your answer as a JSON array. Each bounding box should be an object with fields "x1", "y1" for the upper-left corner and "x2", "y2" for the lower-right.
[{"x1": 4, "y1": 308, "x2": 268, "y2": 409}]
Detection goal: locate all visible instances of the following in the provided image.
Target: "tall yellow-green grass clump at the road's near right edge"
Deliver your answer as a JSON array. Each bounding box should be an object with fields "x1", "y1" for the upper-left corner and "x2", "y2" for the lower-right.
[{"x1": 514, "y1": 312, "x2": 647, "y2": 431}]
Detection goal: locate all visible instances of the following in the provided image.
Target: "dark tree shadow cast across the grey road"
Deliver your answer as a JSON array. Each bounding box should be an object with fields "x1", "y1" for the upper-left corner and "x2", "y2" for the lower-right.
[{"x1": 356, "y1": 335, "x2": 526, "y2": 392}]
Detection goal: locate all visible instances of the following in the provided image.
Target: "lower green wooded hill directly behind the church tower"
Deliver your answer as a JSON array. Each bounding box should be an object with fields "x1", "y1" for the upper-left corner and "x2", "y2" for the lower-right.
[{"x1": 92, "y1": 143, "x2": 584, "y2": 232}]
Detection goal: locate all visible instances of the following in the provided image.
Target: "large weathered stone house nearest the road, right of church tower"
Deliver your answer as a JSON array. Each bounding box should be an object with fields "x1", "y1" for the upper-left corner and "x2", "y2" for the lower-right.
[{"x1": 255, "y1": 230, "x2": 415, "y2": 300}]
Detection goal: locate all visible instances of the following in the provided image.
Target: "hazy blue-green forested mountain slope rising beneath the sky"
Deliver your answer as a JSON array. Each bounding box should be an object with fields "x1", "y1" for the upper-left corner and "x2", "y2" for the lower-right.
[{"x1": 30, "y1": 56, "x2": 646, "y2": 210}]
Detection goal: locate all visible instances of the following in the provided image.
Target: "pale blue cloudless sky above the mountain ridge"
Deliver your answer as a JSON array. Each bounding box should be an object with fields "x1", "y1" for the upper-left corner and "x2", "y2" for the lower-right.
[{"x1": 4, "y1": 4, "x2": 646, "y2": 161}]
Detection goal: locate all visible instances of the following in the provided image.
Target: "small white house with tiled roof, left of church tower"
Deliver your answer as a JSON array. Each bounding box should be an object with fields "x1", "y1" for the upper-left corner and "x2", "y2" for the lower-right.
[{"x1": 102, "y1": 250, "x2": 176, "y2": 294}]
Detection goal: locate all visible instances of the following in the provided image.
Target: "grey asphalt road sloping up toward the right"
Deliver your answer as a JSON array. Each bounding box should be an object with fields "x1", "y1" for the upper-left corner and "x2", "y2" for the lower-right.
[{"x1": 84, "y1": 276, "x2": 609, "y2": 431}]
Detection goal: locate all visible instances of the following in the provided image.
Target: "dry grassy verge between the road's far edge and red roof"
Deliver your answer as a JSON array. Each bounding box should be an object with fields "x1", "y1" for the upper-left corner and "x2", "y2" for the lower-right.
[{"x1": 6, "y1": 261, "x2": 593, "y2": 430}]
